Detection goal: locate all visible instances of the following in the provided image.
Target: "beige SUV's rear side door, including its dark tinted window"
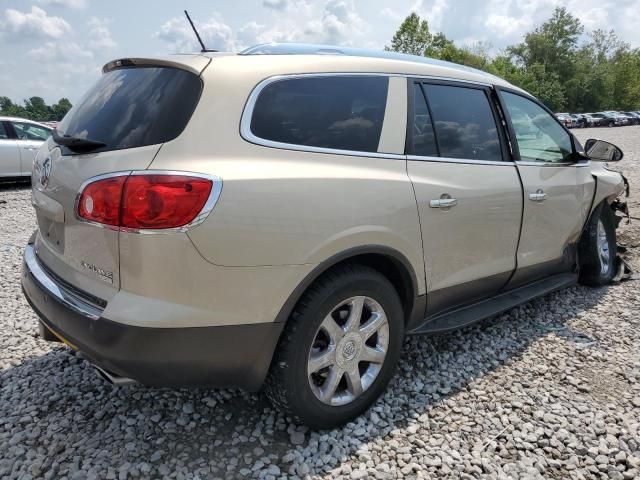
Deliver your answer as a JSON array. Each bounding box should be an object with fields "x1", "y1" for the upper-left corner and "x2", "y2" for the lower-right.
[{"x1": 407, "y1": 80, "x2": 522, "y2": 315}]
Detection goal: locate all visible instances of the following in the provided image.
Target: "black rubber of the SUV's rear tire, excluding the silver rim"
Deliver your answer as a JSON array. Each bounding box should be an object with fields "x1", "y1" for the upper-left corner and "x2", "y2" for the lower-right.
[{"x1": 286, "y1": 275, "x2": 404, "y2": 428}]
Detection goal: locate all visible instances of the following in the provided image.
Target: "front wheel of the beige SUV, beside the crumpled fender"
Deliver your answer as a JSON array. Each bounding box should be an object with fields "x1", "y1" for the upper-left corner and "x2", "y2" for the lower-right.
[{"x1": 578, "y1": 202, "x2": 616, "y2": 287}]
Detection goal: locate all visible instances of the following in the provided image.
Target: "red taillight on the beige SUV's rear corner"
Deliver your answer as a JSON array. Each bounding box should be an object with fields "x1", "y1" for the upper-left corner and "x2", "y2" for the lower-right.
[{"x1": 78, "y1": 171, "x2": 220, "y2": 230}]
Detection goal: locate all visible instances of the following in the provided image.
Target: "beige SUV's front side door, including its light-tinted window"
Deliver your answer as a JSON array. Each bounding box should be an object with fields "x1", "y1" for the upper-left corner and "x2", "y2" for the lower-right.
[{"x1": 501, "y1": 91, "x2": 595, "y2": 286}]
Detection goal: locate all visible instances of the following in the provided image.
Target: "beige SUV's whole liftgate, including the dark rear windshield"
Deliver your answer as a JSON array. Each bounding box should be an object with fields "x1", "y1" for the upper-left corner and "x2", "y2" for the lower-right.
[{"x1": 33, "y1": 62, "x2": 202, "y2": 300}]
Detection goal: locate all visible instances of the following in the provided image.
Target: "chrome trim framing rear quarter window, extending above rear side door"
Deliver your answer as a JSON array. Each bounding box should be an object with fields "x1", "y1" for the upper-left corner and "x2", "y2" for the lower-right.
[{"x1": 240, "y1": 72, "x2": 493, "y2": 160}]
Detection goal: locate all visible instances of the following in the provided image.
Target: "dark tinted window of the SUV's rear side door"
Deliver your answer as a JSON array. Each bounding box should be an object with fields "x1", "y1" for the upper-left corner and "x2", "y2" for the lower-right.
[{"x1": 424, "y1": 84, "x2": 503, "y2": 161}]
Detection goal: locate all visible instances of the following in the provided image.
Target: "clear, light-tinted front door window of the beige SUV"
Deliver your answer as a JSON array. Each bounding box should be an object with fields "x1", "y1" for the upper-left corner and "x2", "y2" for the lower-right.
[{"x1": 502, "y1": 92, "x2": 573, "y2": 163}]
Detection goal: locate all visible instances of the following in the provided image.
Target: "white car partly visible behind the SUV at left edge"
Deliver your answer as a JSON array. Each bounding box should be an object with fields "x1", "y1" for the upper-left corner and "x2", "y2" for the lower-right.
[{"x1": 0, "y1": 117, "x2": 52, "y2": 178}]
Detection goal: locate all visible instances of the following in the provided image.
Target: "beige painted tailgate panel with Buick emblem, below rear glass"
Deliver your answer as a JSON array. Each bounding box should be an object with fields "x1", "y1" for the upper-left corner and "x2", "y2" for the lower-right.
[{"x1": 32, "y1": 141, "x2": 160, "y2": 300}]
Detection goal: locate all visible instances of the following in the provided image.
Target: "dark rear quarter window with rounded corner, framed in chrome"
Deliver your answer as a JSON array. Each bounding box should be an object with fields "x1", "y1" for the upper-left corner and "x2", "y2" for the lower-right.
[{"x1": 251, "y1": 76, "x2": 389, "y2": 152}]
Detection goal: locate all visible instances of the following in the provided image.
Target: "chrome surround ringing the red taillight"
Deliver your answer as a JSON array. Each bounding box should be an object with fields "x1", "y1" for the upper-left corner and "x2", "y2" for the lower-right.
[{"x1": 73, "y1": 170, "x2": 222, "y2": 235}]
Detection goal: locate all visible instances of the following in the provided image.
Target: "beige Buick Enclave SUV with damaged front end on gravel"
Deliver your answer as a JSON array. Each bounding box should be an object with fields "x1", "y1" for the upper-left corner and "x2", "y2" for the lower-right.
[{"x1": 22, "y1": 44, "x2": 626, "y2": 428}]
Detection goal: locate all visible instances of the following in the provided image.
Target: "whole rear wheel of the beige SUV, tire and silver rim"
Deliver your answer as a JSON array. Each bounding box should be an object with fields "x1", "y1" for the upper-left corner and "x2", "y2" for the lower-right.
[{"x1": 265, "y1": 265, "x2": 404, "y2": 429}]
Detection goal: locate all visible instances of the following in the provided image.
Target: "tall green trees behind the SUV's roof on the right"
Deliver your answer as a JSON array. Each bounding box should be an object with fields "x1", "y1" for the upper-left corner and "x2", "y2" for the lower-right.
[{"x1": 385, "y1": 7, "x2": 640, "y2": 112}]
